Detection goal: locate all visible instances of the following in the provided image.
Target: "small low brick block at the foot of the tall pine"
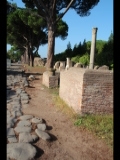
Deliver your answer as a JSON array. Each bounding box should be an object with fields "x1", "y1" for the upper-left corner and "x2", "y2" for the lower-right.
[{"x1": 42, "y1": 71, "x2": 59, "y2": 88}]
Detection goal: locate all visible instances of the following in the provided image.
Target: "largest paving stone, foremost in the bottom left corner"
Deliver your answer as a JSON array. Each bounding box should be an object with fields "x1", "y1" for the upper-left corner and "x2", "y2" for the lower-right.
[{"x1": 7, "y1": 143, "x2": 37, "y2": 160}]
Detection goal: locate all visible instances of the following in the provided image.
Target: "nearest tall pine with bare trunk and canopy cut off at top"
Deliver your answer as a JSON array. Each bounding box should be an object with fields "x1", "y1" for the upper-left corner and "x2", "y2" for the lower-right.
[{"x1": 22, "y1": 0, "x2": 99, "y2": 68}]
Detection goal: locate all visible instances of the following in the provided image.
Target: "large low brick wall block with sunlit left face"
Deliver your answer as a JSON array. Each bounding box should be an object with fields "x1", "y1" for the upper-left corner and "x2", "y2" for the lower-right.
[{"x1": 59, "y1": 68, "x2": 113, "y2": 114}]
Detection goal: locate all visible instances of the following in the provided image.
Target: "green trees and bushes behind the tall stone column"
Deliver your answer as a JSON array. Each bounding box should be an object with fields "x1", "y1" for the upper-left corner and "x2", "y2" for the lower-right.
[{"x1": 55, "y1": 33, "x2": 114, "y2": 69}]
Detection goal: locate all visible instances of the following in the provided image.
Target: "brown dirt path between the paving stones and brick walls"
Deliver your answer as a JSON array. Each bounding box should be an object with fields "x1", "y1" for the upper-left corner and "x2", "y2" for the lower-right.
[{"x1": 23, "y1": 73, "x2": 113, "y2": 160}]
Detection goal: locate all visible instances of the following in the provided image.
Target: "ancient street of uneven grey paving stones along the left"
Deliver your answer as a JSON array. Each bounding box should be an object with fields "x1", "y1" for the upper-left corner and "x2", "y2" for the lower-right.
[{"x1": 7, "y1": 64, "x2": 50, "y2": 160}]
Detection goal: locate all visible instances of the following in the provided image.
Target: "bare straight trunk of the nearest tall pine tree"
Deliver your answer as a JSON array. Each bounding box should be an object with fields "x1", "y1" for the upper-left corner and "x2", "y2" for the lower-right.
[{"x1": 47, "y1": 21, "x2": 55, "y2": 69}]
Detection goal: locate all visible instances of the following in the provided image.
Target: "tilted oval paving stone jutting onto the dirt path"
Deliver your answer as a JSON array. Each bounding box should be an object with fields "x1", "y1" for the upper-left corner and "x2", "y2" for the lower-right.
[{"x1": 35, "y1": 129, "x2": 51, "y2": 140}]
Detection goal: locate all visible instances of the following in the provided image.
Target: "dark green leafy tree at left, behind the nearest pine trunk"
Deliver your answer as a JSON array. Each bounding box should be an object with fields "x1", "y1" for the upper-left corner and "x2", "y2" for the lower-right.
[{"x1": 7, "y1": 6, "x2": 68, "y2": 66}]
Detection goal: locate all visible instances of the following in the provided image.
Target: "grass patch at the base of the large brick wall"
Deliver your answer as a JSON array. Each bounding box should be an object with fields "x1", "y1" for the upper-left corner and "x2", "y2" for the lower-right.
[{"x1": 74, "y1": 115, "x2": 113, "y2": 146}]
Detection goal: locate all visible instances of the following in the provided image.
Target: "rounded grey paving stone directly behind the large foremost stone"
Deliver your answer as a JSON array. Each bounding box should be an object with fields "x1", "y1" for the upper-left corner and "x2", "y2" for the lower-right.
[{"x1": 19, "y1": 133, "x2": 38, "y2": 143}]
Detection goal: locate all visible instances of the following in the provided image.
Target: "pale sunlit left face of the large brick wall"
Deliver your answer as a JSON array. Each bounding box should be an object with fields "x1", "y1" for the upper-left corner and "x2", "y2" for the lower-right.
[{"x1": 59, "y1": 67, "x2": 85, "y2": 112}]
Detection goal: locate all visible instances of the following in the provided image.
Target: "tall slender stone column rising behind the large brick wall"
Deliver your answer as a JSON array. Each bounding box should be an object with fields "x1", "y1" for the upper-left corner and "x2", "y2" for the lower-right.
[{"x1": 89, "y1": 28, "x2": 98, "y2": 69}]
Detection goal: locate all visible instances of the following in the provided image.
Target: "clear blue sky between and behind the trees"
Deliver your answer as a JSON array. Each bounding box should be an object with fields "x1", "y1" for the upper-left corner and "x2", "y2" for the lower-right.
[{"x1": 7, "y1": 0, "x2": 114, "y2": 58}]
